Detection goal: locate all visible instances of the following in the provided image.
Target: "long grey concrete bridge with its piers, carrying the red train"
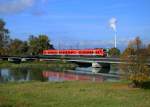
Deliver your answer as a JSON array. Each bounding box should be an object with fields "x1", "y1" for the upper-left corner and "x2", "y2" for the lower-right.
[{"x1": 0, "y1": 56, "x2": 150, "y2": 67}]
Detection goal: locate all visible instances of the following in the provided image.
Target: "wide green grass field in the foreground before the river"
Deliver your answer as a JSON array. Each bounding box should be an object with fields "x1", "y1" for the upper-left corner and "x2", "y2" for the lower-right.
[{"x1": 0, "y1": 82, "x2": 150, "y2": 107}]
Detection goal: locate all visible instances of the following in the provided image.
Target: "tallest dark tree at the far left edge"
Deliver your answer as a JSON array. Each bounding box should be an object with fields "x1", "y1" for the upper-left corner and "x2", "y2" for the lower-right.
[{"x1": 0, "y1": 19, "x2": 10, "y2": 55}]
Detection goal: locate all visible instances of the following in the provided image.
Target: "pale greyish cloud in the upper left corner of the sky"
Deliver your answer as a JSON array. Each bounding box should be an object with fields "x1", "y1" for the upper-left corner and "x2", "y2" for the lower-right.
[{"x1": 0, "y1": 0, "x2": 35, "y2": 14}]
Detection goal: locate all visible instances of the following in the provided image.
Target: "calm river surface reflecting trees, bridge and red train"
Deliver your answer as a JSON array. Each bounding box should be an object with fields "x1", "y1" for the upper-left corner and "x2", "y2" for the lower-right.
[{"x1": 0, "y1": 64, "x2": 119, "y2": 82}]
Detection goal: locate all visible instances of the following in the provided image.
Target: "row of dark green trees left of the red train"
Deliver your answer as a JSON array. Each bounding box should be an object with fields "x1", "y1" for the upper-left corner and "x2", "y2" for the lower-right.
[{"x1": 0, "y1": 19, "x2": 54, "y2": 56}]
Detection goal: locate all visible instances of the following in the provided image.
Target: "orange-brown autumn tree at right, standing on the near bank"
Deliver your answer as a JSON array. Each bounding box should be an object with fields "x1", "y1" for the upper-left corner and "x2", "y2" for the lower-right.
[{"x1": 121, "y1": 37, "x2": 150, "y2": 87}]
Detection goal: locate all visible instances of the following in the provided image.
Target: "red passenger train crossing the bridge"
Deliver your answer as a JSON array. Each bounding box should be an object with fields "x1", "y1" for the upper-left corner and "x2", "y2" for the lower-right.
[{"x1": 43, "y1": 49, "x2": 107, "y2": 57}]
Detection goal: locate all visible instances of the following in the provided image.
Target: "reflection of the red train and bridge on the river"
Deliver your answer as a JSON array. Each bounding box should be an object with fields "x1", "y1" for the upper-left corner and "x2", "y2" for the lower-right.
[{"x1": 43, "y1": 68, "x2": 119, "y2": 82}]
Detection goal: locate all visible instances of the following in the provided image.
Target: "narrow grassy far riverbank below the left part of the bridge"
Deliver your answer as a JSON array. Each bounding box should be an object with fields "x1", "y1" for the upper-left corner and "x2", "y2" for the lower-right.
[{"x1": 0, "y1": 61, "x2": 76, "y2": 70}]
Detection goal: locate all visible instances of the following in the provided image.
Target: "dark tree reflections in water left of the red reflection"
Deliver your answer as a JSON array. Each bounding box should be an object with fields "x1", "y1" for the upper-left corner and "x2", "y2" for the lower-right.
[{"x1": 0, "y1": 68, "x2": 45, "y2": 82}]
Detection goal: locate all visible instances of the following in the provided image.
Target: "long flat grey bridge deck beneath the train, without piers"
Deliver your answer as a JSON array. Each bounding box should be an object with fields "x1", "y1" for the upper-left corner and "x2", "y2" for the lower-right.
[{"x1": 0, "y1": 56, "x2": 150, "y2": 65}]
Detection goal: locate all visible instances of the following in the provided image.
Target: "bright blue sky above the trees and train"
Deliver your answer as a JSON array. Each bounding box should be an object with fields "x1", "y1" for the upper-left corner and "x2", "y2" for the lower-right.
[{"x1": 0, "y1": 0, "x2": 150, "y2": 48}]
